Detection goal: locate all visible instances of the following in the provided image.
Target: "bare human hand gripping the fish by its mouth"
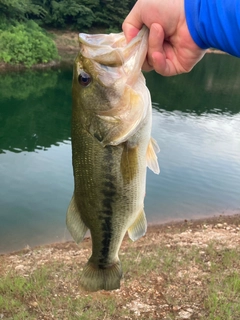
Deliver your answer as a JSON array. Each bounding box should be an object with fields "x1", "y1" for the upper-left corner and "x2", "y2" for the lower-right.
[{"x1": 122, "y1": 0, "x2": 206, "y2": 76}]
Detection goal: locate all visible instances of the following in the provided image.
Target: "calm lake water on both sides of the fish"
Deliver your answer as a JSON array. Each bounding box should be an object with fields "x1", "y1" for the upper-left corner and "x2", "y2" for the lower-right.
[{"x1": 0, "y1": 54, "x2": 240, "y2": 253}]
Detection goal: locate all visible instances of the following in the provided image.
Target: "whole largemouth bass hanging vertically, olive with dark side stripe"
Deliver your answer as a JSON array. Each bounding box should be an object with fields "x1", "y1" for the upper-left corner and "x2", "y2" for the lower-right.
[{"x1": 66, "y1": 26, "x2": 159, "y2": 291}]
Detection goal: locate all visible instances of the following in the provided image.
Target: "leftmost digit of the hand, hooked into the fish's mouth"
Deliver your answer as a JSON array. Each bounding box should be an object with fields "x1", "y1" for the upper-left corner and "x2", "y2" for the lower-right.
[{"x1": 122, "y1": 2, "x2": 143, "y2": 42}]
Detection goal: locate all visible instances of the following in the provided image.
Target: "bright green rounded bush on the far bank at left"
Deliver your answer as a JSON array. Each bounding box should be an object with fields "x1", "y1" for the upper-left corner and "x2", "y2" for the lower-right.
[{"x1": 0, "y1": 20, "x2": 58, "y2": 67}]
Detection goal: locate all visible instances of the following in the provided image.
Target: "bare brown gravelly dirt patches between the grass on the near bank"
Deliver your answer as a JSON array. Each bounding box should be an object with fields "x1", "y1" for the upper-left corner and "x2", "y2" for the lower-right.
[{"x1": 0, "y1": 214, "x2": 240, "y2": 320}]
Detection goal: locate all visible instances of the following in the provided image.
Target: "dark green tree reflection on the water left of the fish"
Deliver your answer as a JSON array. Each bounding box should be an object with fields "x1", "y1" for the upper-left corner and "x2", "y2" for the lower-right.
[{"x1": 0, "y1": 68, "x2": 72, "y2": 153}]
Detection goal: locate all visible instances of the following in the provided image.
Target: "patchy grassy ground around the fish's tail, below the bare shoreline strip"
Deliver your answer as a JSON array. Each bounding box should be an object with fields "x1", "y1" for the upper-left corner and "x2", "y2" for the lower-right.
[{"x1": 0, "y1": 228, "x2": 240, "y2": 320}]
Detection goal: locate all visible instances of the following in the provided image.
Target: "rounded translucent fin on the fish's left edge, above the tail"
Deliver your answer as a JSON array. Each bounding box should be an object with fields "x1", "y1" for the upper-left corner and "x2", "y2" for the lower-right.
[{"x1": 66, "y1": 195, "x2": 88, "y2": 243}]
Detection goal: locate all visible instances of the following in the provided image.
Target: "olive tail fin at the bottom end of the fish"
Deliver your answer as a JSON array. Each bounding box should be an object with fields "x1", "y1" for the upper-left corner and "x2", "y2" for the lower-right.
[{"x1": 80, "y1": 260, "x2": 122, "y2": 292}]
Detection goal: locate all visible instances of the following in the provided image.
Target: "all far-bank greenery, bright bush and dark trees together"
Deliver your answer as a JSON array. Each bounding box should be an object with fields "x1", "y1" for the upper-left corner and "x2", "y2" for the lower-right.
[{"x1": 0, "y1": 0, "x2": 135, "y2": 67}]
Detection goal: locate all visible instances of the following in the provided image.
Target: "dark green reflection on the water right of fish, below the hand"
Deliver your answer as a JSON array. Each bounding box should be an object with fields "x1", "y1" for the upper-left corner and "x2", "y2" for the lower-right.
[{"x1": 145, "y1": 54, "x2": 240, "y2": 115}]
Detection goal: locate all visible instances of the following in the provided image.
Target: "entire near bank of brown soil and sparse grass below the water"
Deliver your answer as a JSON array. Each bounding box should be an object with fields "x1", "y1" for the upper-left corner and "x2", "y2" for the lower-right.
[{"x1": 0, "y1": 214, "x2": 240, "y2": 320}]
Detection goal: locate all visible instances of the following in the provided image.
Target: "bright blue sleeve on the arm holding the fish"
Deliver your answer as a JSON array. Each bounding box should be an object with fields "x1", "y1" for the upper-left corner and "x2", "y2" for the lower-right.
[{"x1": 185, "y1": 0, "x2": 240, "y2": 57}]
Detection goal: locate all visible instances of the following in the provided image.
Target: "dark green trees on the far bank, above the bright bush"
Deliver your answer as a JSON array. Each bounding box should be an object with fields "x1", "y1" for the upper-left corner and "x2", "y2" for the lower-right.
[{"x1": 0, "y1": 0, "x2": 135, "y2": 30}]
